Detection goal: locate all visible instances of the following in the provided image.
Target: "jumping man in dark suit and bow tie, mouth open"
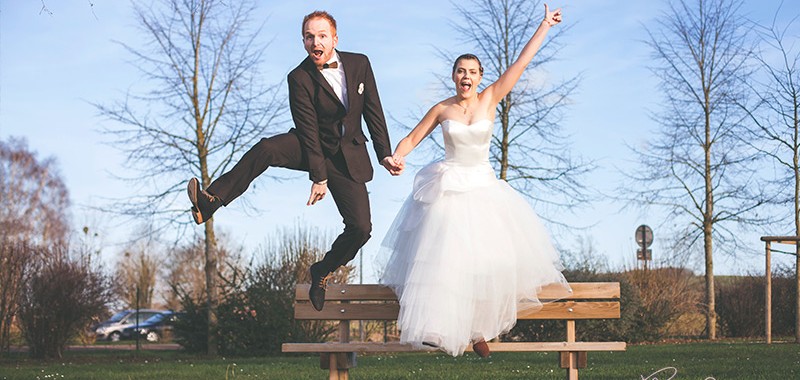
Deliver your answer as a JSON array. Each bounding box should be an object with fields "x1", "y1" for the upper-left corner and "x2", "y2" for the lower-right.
[{"x1": 188, "y1": 11, "x2": 403, "y2": 310}]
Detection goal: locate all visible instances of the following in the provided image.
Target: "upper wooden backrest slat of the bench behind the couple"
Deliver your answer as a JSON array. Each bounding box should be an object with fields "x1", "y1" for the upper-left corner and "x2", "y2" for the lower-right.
[{"x1": 295, "y1": 282, "x2": 619, "y2": 302}]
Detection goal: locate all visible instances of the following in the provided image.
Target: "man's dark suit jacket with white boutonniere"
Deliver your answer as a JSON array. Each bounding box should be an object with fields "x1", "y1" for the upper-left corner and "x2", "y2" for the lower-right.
[{"x1": 288, "y1": 52, "x2": 392, "y2": 182}]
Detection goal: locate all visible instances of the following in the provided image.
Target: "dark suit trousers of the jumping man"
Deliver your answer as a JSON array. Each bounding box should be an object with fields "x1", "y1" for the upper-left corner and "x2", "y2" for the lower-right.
[{"x1": 206, "y1": 132, "x2": 372, "y2": 272}]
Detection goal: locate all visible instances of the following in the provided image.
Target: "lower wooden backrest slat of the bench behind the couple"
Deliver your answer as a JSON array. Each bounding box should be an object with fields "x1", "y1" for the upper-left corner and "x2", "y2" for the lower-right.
[{"x1": 294, "y1": 301, "x2": 620, "y2": 320}]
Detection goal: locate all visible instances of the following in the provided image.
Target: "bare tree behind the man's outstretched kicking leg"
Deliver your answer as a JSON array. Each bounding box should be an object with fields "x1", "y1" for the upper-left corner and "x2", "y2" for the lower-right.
[{"x1": 96, "y1": 0, "x2": 285, "y2": 355}]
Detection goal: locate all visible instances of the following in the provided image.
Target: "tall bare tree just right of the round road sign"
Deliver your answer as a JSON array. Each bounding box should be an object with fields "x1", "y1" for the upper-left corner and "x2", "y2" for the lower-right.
[{"x1": 619, "y1": 0, "x2": 767, "y2": 339}]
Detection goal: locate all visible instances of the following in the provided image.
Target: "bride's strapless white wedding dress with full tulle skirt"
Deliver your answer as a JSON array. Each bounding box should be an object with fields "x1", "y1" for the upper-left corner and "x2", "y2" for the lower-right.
[{"x1": 380, "y1": 120, "x2": 570, "y2": 356}]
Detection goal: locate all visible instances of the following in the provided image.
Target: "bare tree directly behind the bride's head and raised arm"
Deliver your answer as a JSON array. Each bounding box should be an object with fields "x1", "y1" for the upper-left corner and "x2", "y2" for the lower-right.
[{"x1": 416, "y1": 0, "x2": 594, "y2": 221}]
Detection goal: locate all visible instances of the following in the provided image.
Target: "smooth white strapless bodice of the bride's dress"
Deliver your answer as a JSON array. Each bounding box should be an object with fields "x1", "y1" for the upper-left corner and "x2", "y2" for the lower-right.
[{"x1": 442, "y1": 119, "x2": 492, "y2": 165}]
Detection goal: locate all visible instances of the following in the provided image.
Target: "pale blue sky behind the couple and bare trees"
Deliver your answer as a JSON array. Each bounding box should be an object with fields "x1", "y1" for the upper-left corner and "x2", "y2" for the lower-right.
[{"x1": 0, "y1": 0, "x2": 800, "y2": 280}]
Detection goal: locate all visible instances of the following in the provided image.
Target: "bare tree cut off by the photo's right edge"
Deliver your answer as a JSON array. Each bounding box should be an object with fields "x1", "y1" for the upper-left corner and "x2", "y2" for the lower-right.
[{"x1": 742, "y1": 9, "x2": 800, "y2": 342}]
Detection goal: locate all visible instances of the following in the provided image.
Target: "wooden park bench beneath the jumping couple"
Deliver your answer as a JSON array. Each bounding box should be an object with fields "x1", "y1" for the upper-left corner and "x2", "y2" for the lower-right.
[{"x1": 282, "y1": 282, "x2": 626, "y2": 380}]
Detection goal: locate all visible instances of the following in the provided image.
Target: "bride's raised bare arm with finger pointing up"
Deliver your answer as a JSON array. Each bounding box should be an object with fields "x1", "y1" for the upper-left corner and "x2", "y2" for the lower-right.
[{"x1": 482, "y1": 4, "x2": 561, "y2": 104}]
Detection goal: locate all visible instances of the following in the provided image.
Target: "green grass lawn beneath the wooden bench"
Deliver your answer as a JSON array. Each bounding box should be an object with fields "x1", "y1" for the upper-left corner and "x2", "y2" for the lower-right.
[{"x1": 0, "y1": 342, "x2": 800, "y2": 380}]
